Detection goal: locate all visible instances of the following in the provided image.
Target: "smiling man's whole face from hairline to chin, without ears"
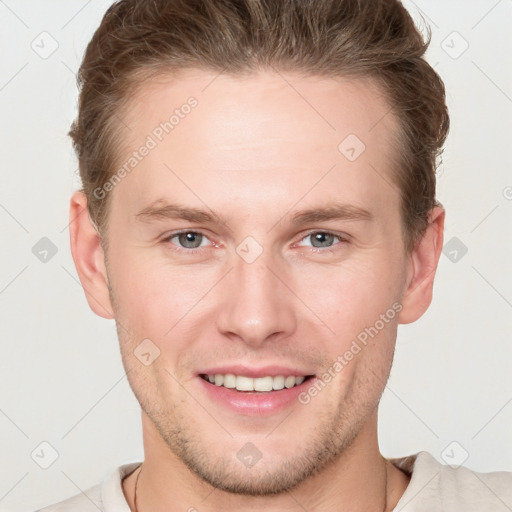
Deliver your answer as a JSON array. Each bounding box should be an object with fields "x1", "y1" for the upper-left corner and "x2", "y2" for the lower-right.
[{"x1": 103, "y1": 71, "x2": 408, "y2": 494}]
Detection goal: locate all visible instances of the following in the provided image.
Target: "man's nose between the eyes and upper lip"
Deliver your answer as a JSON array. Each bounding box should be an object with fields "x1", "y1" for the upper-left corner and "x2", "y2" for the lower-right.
[{"x1": 217, "y1": 247, "x2": 297, "y2": 348}]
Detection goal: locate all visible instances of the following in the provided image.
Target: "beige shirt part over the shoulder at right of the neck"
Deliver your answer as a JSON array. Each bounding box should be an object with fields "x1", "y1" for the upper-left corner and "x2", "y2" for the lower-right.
[{"x1": 391, "y1": 452, "x2": 512, "y2": 512}]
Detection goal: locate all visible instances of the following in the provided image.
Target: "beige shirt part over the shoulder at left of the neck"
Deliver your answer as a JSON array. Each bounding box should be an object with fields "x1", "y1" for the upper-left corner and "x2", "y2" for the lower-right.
[{"x1": 36, "y1": 462, "x2": 140, "y2": 512}]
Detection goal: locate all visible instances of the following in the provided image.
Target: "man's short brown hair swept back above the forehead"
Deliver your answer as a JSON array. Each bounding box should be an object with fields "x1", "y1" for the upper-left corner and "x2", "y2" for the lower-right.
[{"x1": 69, "y1": 0, "x2": 449, "y2": 251}]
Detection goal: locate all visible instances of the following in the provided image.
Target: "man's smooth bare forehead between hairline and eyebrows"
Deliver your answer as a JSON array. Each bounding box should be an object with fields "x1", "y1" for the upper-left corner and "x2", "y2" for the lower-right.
[{"x1": 110, "y1": 70, "x2": 397, "y2": 219}]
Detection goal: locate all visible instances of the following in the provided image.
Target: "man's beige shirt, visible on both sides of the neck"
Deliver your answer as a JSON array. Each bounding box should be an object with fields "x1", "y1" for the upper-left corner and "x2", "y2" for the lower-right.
[{"x1": 38, "y1": 452, "x2": 512, "y2": 512}]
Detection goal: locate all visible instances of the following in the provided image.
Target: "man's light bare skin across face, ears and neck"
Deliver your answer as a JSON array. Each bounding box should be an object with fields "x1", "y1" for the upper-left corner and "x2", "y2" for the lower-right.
[{"x1": 70, "y1": 70, "x2": 445, "y2": 512}]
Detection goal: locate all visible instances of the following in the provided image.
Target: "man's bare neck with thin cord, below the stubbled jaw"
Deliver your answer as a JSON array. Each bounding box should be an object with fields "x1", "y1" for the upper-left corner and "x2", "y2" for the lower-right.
[{"x1": 123, "y1": 411, "x2": 409, "y2": 512}]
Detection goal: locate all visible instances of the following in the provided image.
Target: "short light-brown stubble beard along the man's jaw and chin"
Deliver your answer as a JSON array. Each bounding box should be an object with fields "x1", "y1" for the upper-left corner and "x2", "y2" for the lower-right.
[{"x1": 139, "y1": 386, "x2": 366, "y2": 496}]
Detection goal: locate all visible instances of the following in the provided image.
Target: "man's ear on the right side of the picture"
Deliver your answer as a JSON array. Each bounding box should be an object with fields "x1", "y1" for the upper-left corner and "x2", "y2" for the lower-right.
[{"x1": 398, "y1": 206, "x2": 445, "y2": 324}]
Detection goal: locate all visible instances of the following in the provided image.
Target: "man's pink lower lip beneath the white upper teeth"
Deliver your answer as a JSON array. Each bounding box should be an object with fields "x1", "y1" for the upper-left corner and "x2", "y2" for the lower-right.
[{"x1": 198, "y1": 377, "x2": 315, "y2": 417}]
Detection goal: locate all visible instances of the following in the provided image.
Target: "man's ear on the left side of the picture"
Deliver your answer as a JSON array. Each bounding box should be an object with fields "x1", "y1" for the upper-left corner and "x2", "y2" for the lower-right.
[{"x1": 69, "y1": 192, "x2": 114, "y2": 319}]
